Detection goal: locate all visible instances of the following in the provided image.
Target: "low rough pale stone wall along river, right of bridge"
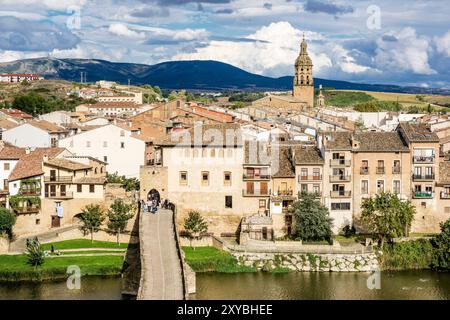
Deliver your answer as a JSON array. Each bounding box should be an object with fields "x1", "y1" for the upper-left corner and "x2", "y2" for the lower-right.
[{"x1": 231, "y1": 251, "x2": 379, "y2": 272}]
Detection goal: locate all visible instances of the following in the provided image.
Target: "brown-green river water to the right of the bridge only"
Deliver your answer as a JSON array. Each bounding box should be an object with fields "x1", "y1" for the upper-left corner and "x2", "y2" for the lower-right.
[{"x1": 191, "y1": 271, "x2": 450, "y2": 300}]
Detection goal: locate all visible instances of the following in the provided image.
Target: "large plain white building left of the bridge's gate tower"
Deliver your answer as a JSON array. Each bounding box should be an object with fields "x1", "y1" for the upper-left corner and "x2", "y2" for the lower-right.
[{"x1": 59, "y1": 124, "x2": 145, "y2": 178}]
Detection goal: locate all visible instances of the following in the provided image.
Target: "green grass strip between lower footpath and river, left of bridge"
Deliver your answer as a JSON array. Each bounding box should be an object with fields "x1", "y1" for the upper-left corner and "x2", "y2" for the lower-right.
[{"x1": 0, "y1": 255, "x2": 123, "y2": 281}]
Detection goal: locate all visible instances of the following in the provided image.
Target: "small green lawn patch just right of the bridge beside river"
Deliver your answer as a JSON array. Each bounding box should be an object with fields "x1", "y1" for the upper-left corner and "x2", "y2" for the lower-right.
[{"x1": 183, "y1": 247, "x2": 256, "y2": 273}]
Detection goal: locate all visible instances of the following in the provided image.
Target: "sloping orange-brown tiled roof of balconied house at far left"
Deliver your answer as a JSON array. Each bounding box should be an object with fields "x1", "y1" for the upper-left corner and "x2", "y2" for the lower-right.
[{"x1": 8, "y1": 148, "x2": 65, "y2": 181}]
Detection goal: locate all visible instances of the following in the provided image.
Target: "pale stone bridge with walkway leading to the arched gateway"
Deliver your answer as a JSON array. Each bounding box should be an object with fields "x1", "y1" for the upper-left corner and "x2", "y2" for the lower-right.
[{"x1": 137, "y1": 209, "x2": 195, "y2": 300}]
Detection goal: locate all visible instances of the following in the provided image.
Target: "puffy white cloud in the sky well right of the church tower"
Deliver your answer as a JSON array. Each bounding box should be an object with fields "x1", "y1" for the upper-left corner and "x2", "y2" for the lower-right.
[{"x1": 375, "y1": 27, "x2": 436, "y2": 75}]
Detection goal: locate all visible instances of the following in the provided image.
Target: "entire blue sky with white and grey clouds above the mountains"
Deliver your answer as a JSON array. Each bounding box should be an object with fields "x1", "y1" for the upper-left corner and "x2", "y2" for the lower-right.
[{"x1": 0, "y1": 0, "x2": 450, "y2": 88}]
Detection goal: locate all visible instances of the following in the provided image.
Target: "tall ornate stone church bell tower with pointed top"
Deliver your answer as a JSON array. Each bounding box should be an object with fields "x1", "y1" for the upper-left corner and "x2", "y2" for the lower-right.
[{"x1": 293, "y1": 36, "x2": 314, "y2": 108}]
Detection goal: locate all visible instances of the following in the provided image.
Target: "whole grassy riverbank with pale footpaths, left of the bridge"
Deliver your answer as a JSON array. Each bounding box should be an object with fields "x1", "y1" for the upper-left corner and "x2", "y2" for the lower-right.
[{"x1": 0, "y1": 239, "x2": 127, "y2": 282}]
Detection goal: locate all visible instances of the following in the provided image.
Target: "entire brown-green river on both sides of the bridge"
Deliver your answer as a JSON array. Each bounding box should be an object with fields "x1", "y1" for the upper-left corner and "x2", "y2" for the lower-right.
[{"x1": 0, "y1": 271, "x2": 450, "y2": 300}]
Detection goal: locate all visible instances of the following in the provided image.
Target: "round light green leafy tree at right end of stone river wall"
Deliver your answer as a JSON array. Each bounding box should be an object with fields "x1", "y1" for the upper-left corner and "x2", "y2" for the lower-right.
[{"x1": 361, "y1": 192, "x2": 416, "y2": 248}]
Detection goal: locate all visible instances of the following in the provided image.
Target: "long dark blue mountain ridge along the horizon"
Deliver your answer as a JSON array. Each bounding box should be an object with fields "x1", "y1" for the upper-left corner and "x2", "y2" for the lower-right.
[{"x1": 0, "y1": 58, "x2": 450, "y2": 94}]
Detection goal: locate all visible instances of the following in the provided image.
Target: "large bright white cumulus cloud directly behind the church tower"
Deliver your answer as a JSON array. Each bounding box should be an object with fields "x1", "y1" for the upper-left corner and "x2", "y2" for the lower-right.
[{"x1": 172, "y1": 22, "x2": 332, "y2": 76}]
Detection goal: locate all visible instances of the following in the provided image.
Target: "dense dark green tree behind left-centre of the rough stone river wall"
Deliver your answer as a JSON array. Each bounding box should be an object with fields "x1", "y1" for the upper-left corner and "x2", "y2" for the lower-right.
[{"x1": 291, "y1": 192, "x2": 333, "y2": 242}]
